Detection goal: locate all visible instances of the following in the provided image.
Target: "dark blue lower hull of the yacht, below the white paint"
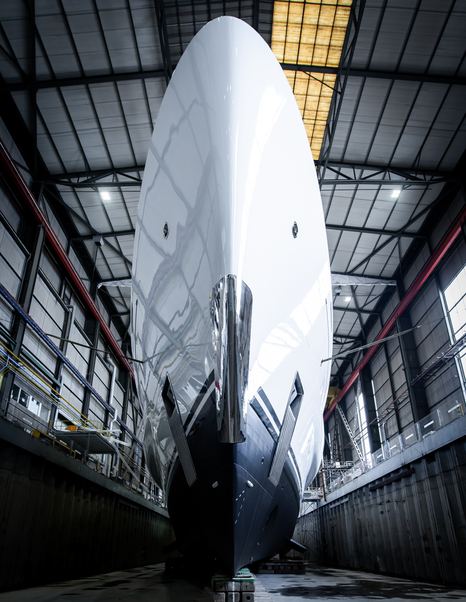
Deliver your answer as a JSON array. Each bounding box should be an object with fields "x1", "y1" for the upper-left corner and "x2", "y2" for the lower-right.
[{"x1": 168, "y1": 386, "x2": 300, "y2": 575}]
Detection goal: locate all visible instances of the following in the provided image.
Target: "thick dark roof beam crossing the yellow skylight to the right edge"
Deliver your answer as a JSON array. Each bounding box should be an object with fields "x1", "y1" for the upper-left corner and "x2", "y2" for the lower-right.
[{"x1": 280, "y1": 63, "x2": 466, "y2": 86}]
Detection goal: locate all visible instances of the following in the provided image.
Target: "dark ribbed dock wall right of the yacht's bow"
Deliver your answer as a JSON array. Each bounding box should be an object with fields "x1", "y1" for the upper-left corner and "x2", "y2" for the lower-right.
[{"x1": 295, "y1": 439, "x2": 466, "y2": 586}]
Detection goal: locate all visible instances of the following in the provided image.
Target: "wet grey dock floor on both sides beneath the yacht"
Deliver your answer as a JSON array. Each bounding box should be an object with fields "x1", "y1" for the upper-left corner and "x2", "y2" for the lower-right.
[{"x1": 0, "y1": 564, "x2": 466, "y2": 602}]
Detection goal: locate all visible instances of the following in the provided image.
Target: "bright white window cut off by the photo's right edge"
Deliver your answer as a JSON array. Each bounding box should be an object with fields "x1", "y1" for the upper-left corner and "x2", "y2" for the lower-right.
[{"x1": 443, "y1": 266, "x2": 466, "y2": 381}]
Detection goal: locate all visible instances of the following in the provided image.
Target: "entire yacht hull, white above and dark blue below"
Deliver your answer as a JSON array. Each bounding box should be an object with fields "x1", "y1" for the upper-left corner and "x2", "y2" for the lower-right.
[{"x1": 132, "y1": 18, "x2": 332, "y2": 573}]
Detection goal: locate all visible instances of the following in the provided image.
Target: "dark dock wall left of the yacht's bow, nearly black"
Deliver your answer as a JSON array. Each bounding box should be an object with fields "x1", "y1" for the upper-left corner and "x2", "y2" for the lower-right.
[{"x1": 0, "y1": 440, "x2": 173, "y2": 590}]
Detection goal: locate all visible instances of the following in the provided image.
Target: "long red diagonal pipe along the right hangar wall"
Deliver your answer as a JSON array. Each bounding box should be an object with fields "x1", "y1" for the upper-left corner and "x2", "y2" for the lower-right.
[{"x1": 324, "y1": 200, "x2": 466, "y2": 420}]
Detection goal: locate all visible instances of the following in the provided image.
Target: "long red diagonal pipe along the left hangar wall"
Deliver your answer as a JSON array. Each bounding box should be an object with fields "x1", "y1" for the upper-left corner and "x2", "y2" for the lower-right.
[{"x1": 0, "y1": 142, "x2": 134, "y2": 376}]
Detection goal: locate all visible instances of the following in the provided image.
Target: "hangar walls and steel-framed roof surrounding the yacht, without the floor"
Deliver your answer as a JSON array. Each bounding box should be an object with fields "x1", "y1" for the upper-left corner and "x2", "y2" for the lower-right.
[{"x1": 0, "y1": 0, "x2": 466, "y2": 589}]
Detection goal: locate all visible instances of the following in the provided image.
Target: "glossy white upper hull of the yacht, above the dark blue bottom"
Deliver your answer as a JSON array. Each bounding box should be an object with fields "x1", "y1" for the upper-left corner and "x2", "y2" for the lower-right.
[{"x1": 132, "y1": 17, "x2": 332, "y2": 486}]
